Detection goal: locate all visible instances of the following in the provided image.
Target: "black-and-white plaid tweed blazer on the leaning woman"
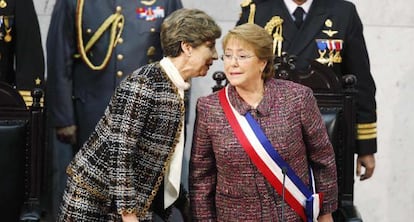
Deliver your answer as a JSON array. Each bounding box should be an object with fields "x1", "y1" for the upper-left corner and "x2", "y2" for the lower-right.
[{"x1": 60, "y1": 62, "x2": 184, "y2": 221}]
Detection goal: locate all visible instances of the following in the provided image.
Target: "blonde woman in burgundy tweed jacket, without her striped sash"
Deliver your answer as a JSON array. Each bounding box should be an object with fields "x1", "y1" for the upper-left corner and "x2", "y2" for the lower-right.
[{"x1": 189, "y1": 24, "x2": 338, "y2": 221}]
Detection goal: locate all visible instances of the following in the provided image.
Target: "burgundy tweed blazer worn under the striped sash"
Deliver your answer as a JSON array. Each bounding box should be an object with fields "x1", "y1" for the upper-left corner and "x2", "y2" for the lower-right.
[{"x1": 189, "y1": 79, "x2": 338, "y2": 221}]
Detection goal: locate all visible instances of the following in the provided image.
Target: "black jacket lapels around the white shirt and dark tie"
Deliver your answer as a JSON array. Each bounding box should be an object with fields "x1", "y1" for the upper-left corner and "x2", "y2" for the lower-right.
[{"x1": 281, "y1": 0, "x2": 329, "y2": 55}]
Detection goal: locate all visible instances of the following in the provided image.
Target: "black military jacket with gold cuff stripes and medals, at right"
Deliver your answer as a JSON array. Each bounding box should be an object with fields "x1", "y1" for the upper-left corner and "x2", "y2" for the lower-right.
[{"x1": 237, "y1": 0, "x2": 377, "y2": 154}]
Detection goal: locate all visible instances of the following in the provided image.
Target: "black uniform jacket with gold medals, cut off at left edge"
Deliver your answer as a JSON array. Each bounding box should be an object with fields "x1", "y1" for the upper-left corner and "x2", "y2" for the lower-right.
[{"x1": 0, "y1": 0, "x2": 45, "y2": 91}]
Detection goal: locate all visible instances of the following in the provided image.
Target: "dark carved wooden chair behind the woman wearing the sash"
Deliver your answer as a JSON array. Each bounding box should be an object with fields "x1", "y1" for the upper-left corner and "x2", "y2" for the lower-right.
[{"x1": 213, "y1": 54, "x2": 362, "y2": 222}]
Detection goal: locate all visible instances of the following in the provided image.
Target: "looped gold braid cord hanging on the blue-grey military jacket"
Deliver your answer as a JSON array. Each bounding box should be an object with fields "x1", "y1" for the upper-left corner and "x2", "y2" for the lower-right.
[{"x1": 75, "y1": 0, "x2": 124, "y2": 70}]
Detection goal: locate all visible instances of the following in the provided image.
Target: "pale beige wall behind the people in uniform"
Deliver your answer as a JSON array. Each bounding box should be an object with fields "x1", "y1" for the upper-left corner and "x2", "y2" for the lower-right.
[{"x1": 34, "y1": 0, "x2": 414, "y2": 222}]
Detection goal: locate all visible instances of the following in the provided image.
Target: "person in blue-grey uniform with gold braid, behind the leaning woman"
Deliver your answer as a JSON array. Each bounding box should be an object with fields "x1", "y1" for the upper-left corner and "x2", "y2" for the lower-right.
[{"x1": 47, "y1": 0, "x2": 182, "y2": 220}]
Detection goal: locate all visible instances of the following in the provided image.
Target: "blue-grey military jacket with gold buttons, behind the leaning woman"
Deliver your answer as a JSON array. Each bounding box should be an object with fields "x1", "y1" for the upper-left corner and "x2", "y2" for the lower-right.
[{"x1": 47, "y1": 0, "x2": 182, "y2": 146}]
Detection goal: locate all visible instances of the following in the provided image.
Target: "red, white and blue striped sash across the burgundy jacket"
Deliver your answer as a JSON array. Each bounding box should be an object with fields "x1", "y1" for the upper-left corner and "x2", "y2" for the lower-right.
[{"x1": 218, "y1": 86, "x2": 322, "y2": 222}]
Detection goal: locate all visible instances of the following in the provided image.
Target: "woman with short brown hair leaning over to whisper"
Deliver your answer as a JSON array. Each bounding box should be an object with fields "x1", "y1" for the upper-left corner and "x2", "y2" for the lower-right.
[{"x1": 59, "y1": 9, "x2": 221, "y2": 222}]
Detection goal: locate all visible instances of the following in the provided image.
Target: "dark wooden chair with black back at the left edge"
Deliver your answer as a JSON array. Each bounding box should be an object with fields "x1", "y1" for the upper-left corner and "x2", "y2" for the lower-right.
[{"x1": 0, "y1": 82, "x2": 45, "y2": 221}]
